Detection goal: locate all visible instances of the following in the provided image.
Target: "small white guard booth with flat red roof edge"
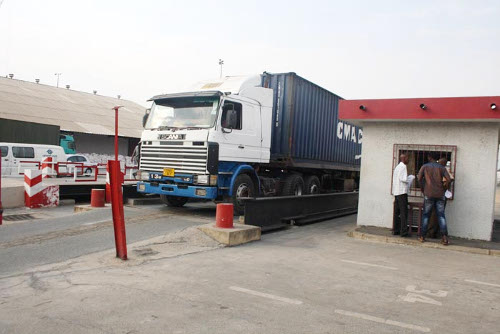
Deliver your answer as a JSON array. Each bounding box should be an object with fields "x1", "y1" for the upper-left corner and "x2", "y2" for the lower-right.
[{"x1": 339, "y1": 96, "x2": 500, "y2": 240}]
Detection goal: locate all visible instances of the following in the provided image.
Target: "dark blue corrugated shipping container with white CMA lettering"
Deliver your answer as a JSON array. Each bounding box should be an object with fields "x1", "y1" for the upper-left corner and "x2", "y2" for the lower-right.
[{"x1": 262, "y1": 73, "x2": 362, "y2": 170}]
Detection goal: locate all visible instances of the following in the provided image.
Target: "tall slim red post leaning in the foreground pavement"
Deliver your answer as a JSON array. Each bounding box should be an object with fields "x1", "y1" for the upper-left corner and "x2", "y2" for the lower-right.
[{"x1": 108, "y1": 160, "x2": 127, "y2": 260}]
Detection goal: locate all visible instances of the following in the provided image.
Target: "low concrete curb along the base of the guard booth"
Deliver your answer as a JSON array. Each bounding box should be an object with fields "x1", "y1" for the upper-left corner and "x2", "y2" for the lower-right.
[{"x1": 347, "y1": 229, "x2": 500, "y2": 257}]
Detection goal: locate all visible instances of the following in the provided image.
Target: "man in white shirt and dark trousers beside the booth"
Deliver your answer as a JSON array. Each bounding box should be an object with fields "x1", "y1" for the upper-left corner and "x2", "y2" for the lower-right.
[{"x1": 392, "y1": 154, "x2": 409, "y2": 237}]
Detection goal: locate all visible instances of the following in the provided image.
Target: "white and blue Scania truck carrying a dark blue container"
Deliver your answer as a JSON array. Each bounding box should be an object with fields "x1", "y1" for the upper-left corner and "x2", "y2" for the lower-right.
[{"x1": 137, "y1": 72, "x2": 363, "y2": 214}]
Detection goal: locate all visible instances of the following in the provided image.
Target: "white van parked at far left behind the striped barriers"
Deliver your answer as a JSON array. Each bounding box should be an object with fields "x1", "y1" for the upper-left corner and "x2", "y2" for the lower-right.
[{"x1": 0, "y1": 143, "x2": 66, "y2": 176}]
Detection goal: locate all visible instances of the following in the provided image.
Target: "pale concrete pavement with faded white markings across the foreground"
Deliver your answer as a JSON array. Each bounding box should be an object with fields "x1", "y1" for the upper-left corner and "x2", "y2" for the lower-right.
[{"x1": 0, "y1": 216, "x2": 500, "y2": 333}]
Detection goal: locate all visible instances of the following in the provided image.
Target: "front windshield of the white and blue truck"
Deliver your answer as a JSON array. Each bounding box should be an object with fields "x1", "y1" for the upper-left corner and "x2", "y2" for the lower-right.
[{"x1": 146, "y1": 97, "x2": 219, "y2": 130}]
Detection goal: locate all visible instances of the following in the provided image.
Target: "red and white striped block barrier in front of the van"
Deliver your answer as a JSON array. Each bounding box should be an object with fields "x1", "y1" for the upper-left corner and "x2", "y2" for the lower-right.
[{"x1": 24, "y1": 169, "x2": 59, "y2": 209}]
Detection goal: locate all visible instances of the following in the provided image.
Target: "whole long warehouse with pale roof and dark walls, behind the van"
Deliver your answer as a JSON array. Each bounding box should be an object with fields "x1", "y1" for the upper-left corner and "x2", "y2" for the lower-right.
[{"x1": 0, "y1": 77, "x2": 145, "y2": 156}]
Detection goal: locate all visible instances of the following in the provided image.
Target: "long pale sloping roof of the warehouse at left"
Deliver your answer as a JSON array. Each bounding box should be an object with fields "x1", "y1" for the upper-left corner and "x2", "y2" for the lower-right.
[{"x1": 0, "y1": 78, "x2": 145, "y2": 138}]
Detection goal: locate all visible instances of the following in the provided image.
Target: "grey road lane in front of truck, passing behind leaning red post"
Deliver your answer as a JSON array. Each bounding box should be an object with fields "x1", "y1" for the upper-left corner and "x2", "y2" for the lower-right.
[{"x1": 0, "y1": 203, "x2": 215, "y2": 276}]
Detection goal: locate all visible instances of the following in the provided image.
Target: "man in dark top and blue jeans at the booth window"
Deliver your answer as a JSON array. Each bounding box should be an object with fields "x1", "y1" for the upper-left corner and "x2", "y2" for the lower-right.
[{"x1": 418, "y1": 153, "x2": 451, "y2": 245}]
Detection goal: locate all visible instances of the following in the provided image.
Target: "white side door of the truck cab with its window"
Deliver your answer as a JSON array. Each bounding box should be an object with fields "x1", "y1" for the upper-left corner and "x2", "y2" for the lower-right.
[{"x1": 219, "y1": 100, "x2": 261, "y2": 162}]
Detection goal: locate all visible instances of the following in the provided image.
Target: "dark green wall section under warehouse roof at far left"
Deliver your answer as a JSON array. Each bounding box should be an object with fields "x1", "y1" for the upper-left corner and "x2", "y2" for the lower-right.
[{"x1": 0, "y1": 118, "x2": 59, "y2": 145}]
